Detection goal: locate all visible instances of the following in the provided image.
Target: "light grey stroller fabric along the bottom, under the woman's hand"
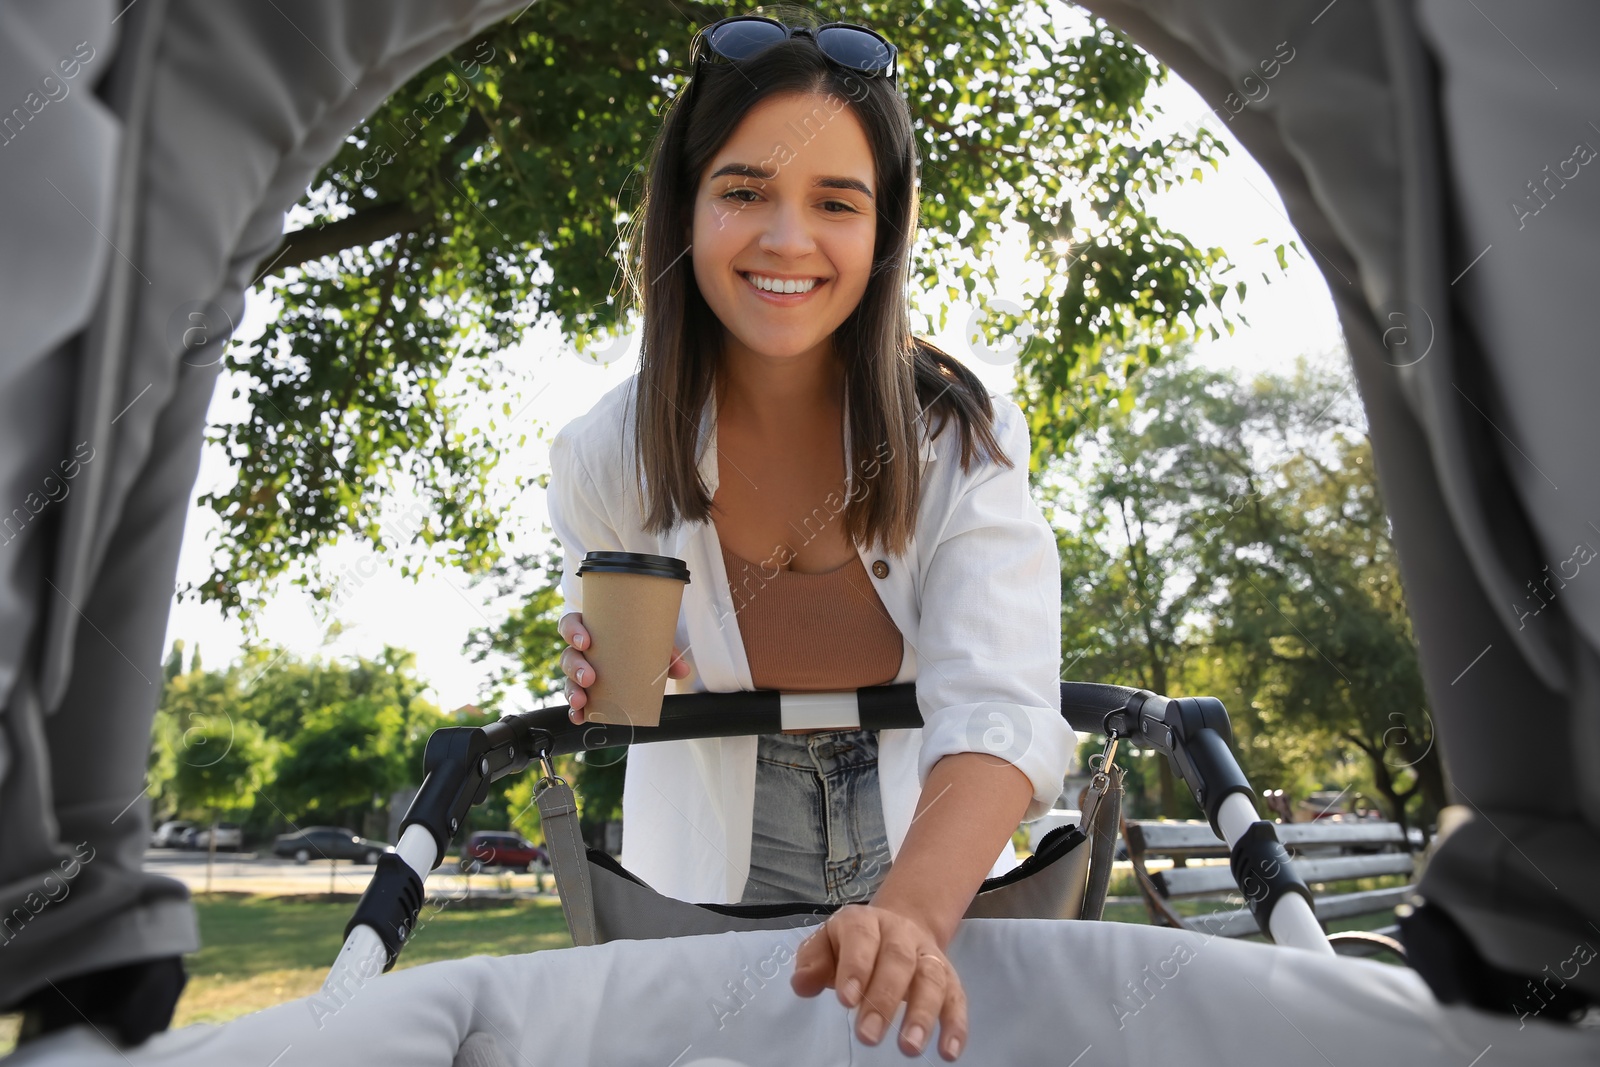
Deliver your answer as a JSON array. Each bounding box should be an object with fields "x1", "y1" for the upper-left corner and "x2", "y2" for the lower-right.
[{"x1": 5, "y1": 918, "x2": 1600, "y2": 1067}]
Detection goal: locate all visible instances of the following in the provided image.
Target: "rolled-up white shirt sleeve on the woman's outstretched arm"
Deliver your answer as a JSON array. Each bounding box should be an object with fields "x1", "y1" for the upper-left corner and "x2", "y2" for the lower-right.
[{"x1": 917, "y1": 397, "x2": 1075, "y2": 822}]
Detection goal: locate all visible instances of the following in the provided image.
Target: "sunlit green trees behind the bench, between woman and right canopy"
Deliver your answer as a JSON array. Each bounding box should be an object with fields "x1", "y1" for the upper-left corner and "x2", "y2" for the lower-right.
[{"x1": 1046, "y1": 358, "x2": 1445, "y2": 824}]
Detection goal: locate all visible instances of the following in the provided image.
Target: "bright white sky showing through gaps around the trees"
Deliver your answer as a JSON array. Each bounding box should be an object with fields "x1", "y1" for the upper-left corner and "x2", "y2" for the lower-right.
[{"x1": 166, "y1": 58, "x2": 1344, "y2": 710}]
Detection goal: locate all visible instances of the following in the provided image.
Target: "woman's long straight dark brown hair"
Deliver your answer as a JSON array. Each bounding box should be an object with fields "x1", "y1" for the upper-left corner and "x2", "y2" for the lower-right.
[{"x1": 614, "y1": 5, "x2": 1013, "y2": 555}]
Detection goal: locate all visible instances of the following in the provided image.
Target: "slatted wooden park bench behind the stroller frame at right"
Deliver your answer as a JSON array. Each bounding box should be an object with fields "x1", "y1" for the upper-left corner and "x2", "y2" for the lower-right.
[{"x1": 1123, "y1": 819, "x2": 1413, "y2": 958}]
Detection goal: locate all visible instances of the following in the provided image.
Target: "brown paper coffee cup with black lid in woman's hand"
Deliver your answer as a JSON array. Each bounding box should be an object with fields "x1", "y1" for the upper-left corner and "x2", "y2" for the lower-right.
[{"x1": 578, "y1": 552, "x2": 690, "y2": 726}]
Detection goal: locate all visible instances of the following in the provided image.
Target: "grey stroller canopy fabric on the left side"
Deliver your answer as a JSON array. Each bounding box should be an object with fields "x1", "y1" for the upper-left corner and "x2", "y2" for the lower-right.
[{"x1": 0, "y1": 0, "x2": 526, "y2": 1008}]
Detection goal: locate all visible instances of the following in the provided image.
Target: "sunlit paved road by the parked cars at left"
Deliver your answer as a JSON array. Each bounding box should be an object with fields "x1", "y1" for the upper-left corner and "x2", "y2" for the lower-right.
[{"x1": 144, "y1": 848, "x2": 555, "y2": 897}]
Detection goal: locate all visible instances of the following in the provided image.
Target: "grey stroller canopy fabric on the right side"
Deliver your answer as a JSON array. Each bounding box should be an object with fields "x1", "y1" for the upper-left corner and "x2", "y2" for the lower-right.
[{"x1": 1083, "y1": 0, "x2": 1600, "y2": 1000}]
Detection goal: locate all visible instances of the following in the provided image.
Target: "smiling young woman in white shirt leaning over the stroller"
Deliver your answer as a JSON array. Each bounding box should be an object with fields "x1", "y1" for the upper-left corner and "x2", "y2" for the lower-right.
[{"x1": 549, "y1": 6, "x2": 1072, "y2": 1059}]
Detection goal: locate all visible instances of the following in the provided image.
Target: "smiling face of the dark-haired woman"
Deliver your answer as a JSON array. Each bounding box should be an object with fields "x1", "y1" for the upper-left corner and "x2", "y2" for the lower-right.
[{"x1": 690, "y1": 93, "x2": 877, "y2": 374}]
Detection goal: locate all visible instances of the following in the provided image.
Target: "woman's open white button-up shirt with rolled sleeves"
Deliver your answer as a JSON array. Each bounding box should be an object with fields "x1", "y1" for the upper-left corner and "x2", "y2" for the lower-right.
[{"x1": 547, "y1": 374, "x2": 1075, "y2": 904}]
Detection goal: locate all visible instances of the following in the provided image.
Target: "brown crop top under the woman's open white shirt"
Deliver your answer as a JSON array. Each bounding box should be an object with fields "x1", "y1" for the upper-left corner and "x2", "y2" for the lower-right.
[{"x1": 722, "y1": 545, "x2": 906, "y2": 693}]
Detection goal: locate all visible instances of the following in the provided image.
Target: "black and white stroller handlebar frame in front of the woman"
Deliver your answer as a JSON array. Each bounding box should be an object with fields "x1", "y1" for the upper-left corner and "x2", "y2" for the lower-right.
[{"x1": 323, "y1": 681, "x2": 1333, "y2": 990}]
